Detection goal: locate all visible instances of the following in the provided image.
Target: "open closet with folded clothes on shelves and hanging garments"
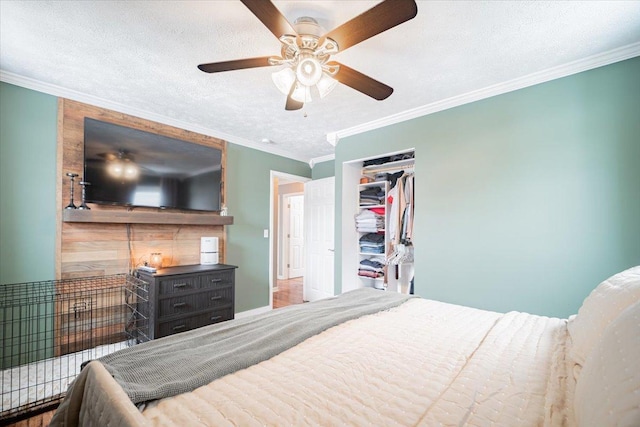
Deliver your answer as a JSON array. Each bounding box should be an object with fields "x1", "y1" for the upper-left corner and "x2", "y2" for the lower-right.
[{"x1": 342, "y1": 149, "x2": 415, "y2": 293}]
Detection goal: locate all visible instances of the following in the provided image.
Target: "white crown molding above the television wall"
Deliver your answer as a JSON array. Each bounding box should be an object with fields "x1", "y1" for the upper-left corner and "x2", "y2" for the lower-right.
[{"x1": 0, "y1": 70, "x2": 309, "y2": 163}]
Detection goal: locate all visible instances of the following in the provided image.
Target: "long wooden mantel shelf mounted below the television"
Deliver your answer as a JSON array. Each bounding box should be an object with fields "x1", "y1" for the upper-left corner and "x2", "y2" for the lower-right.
[{"x1": 62, "y1": 209, "x2": 233, "y2": 225}]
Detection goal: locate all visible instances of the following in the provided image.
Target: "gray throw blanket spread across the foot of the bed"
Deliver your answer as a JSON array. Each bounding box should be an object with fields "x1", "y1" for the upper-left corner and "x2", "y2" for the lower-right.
[{"x1": 98, "y1": 288, "x2": 411, "y2": 403}]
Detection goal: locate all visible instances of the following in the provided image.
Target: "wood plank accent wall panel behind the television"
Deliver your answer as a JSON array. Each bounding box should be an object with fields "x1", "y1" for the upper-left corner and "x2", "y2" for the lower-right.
[{"x1": 56, "y1": 98, "x2": 227, "y2": 279}]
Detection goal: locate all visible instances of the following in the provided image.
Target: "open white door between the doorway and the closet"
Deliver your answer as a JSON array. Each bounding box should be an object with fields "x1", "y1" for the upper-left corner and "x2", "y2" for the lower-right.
[{"x1": 303, "y1": 177, "x2": 335, "y2": 301}]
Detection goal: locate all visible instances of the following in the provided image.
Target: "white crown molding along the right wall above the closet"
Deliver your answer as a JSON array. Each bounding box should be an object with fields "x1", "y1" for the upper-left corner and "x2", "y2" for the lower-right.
[{"x1": 327, "y1": 43, "x2": 640, "y2": 146}]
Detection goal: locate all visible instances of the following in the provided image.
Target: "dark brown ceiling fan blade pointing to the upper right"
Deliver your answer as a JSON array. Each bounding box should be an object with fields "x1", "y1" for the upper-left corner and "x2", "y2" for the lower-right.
[{"x1": 324, "y1": 0, "x2": 418, "y2": 52}]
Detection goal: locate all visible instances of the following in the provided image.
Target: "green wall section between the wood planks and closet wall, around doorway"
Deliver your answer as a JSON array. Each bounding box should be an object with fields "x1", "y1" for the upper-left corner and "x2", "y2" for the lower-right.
[{"x1": 226, "y1": 144, "x2": 311, "y2": 312}]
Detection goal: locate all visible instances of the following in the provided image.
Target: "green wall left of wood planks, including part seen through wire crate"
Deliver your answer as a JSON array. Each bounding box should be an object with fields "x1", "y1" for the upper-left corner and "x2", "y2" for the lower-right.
[{"x1": 0, "y1": 82, "x2": 57, "y2": 369}]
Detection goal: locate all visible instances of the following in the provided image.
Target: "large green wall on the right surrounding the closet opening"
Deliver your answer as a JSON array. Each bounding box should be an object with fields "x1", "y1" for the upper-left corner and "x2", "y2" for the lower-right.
[{"x1": 336, "y1": 58, "x2": 640, "y2": 317}]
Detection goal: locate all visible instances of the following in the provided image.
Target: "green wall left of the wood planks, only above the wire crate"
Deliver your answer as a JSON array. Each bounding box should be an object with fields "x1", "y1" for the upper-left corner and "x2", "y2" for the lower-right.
[{"x1": 0, "y1": 82, "x2": 58, "y2": 284}]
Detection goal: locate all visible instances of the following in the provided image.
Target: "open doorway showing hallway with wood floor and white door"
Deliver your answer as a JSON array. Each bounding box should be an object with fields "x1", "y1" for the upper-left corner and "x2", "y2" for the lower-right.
[{"x1": 269, "y1": 171, "x2": 311, "y2": 308}]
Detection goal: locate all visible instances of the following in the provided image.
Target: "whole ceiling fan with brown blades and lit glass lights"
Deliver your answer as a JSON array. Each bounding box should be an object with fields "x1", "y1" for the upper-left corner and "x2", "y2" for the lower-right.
[{"x1": 198, "y1": 0, "x2": 418, "y2": 110}]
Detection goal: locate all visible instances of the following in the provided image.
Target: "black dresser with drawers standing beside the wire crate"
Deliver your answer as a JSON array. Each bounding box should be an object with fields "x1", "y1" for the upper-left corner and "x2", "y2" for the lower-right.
[{"x1": 138, "y1": 264, "x2": 238, "y2": 339}]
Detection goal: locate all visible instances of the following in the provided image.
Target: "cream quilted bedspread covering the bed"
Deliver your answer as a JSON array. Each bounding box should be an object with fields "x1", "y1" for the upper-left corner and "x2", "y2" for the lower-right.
[{"x1": 51, "y1": 299, "x2": 569, "y2": 426}]
